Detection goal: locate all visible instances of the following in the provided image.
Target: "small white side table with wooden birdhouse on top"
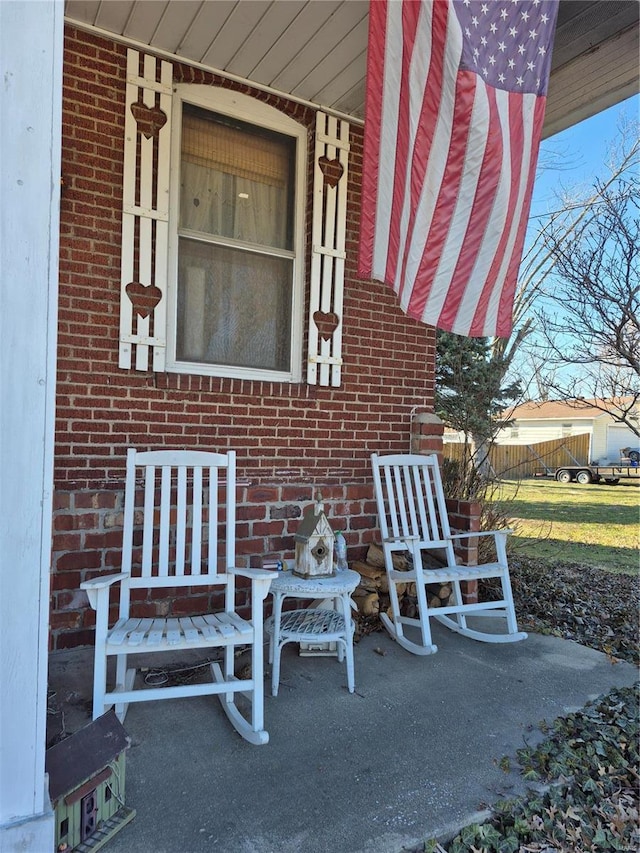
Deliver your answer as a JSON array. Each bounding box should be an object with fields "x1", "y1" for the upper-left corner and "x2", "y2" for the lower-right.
[{"x1": 265, "y1": 569, "x2": 360, "y2": 696}]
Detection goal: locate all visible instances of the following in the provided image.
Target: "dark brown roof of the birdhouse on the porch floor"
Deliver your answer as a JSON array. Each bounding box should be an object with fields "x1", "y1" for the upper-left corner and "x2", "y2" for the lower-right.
[{"x1": 45, "y1": 709, "x2": 131, "y2": 800}]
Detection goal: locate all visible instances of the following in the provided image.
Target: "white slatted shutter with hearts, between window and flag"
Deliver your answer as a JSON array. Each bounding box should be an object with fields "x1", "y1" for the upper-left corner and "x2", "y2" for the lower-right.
[{"x1": 307, "y1": 112, "x2": 349, "y2": 387}]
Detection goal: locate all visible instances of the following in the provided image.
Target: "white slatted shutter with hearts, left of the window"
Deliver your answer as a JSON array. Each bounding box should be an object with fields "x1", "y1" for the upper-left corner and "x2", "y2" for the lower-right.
[{"x1": 119, "y1": 49, "x2": 172, "y2": 371}]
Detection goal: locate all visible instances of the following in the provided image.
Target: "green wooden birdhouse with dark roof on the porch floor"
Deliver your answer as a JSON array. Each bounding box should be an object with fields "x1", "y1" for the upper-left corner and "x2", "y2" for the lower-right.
[{"x1": 45, "y1": 710, "x2": 136, "y2": 853}]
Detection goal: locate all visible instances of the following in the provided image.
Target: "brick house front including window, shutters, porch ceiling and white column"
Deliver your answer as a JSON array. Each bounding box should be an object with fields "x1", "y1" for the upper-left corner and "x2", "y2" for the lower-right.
[{"x1": 0, "y1": 0, "x2": 638, "y2": 850}]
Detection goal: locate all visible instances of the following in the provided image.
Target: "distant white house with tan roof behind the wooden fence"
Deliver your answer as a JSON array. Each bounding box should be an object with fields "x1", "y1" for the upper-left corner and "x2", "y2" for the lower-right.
[{"x1": 496, "y1": 401, "x2": 640, "y2": 464}]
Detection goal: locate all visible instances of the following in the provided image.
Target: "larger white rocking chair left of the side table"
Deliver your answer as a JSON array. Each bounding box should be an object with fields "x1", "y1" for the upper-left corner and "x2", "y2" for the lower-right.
[{"x1": 81, "y1": 449, "x2": 276, "y2": 744}]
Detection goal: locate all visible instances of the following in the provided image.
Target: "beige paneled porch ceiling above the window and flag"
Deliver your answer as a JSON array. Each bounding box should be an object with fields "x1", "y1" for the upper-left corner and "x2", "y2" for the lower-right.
[{"x1": 65, "y1": 0, "x2": 640, "y2": 136}]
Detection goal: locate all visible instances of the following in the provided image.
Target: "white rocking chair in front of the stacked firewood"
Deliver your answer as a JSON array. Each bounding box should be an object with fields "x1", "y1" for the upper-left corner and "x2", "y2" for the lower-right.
[{"x1": 371, "y1": 453, "x2": 527, "y2": 655}]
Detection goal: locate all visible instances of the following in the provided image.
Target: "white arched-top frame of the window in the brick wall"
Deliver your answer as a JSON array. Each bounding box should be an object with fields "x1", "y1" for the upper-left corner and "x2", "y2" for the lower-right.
[{"x1": 166, "y1": 83, "x2": 308, "y2": 382}]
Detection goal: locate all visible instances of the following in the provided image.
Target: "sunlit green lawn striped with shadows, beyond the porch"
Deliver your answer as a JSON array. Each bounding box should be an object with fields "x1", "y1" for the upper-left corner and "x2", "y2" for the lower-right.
[{"x1": 497, "y1": 479, "x2": 640, "y2": 573}]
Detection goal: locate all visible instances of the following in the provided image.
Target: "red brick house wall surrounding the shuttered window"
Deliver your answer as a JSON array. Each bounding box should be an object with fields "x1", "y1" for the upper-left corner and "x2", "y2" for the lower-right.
[{"x1": 51, "y1": 28, "x2": 441, "y2": 648}]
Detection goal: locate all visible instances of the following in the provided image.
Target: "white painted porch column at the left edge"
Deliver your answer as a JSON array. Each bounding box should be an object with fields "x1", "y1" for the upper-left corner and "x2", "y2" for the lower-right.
[{"x1": 0, "y1": 0, "x2": 63, "y2": 853}]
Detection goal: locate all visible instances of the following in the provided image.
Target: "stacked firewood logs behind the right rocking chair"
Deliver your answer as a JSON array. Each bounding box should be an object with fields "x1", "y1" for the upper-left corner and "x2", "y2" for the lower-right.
[{"x1": 351, "y1": 544, "x2": 453, "y2": 618}]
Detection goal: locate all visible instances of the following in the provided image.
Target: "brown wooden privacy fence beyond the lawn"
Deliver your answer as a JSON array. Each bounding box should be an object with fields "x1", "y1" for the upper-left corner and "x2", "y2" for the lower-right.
[{"x1": 442, "y1": 432, "x2": 589, "y2": 480}]
